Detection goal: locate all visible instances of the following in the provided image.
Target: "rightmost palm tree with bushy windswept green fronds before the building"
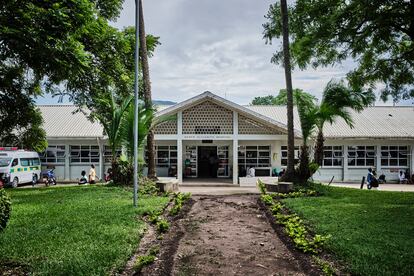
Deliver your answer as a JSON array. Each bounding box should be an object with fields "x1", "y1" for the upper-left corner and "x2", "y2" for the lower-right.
[{"x1": 314, "y1": 80, "x2": 375, "y2": 166}]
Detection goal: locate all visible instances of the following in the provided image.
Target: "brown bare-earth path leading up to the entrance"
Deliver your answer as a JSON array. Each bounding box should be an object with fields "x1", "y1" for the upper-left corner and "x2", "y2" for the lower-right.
[{"x1": 167, "y1": 195, "x2": 307, "y2": 275}]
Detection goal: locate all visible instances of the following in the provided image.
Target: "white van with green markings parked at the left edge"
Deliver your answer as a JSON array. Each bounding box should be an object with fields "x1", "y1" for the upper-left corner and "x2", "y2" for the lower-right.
[{"x1": 0, "y1": 148, "x2": 41, "y2": 188}]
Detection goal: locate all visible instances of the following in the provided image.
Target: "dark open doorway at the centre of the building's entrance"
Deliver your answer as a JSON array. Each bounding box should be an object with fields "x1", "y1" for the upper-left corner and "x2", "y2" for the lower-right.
[{"x1": 197, "y1": 146, "x2": 218, "y2": 178}]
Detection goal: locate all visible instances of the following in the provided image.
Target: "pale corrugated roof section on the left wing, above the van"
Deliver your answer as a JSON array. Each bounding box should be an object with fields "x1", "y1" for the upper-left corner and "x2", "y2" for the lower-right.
[{"x1": 38, "y1": 105, "x2": 103, "y2": 138}]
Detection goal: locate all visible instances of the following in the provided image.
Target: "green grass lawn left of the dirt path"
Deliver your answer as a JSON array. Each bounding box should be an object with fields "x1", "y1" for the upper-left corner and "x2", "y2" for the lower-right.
[{"x1": 0, "y1": 186, "x2": 168, "y2": 275}]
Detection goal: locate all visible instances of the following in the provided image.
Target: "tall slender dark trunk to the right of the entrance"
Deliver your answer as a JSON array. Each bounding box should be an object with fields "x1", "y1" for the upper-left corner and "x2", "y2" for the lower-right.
[{"x1": 280, "y1": 0, "x2": 295, "y2": 181}]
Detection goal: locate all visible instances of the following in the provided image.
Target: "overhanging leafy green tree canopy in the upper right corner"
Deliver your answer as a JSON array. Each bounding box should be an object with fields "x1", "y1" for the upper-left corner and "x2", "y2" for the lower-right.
[{"x1": 263, "y1": 0, "x2": 414, "y2": 102}]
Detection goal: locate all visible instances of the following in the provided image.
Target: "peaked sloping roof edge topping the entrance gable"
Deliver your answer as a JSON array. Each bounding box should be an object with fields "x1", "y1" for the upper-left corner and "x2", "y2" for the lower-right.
[{"x1": 156, "y1": 91, "x2": 301, "y2": 137}]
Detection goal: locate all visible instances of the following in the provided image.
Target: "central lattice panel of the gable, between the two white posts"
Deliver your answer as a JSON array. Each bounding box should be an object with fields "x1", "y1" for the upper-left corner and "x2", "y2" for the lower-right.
[{"x1": 183, "y1": 101, "x2": 233, "y2": 134}]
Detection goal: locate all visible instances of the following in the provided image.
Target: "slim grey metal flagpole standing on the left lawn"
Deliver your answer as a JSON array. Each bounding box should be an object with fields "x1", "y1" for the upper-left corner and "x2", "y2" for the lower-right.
[{"x1": 134, "y1": 0, "x2": 139, "y2": 207}]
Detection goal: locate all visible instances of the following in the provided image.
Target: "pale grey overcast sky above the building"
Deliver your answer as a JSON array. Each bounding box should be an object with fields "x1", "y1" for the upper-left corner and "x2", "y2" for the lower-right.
[{"x1": 38, "y1": 0, "x2": 410, "y2": 104}]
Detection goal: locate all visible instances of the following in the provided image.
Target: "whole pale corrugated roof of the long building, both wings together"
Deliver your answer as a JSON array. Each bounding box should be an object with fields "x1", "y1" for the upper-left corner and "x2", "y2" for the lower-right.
[{"x1": 38, "y1": 101, "x2": 414, "y2": 139}]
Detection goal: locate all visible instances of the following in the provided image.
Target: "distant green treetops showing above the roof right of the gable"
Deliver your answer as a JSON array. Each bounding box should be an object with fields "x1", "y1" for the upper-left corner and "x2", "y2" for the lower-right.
[{"x1": 251, "y1": 89, "x2": 318, "y2": 105}]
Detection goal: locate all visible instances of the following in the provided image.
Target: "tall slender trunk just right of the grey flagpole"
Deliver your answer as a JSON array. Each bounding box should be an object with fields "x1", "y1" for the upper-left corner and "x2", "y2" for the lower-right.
[{"x1": 139, "y1": 0, "x2": 157, "y2": 179}]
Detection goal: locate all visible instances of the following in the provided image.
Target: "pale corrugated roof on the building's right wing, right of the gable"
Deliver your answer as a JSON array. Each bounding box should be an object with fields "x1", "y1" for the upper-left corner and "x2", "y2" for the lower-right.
[{"x1": 246, "y1": 106, "x2": 414, "y2": 139}]
